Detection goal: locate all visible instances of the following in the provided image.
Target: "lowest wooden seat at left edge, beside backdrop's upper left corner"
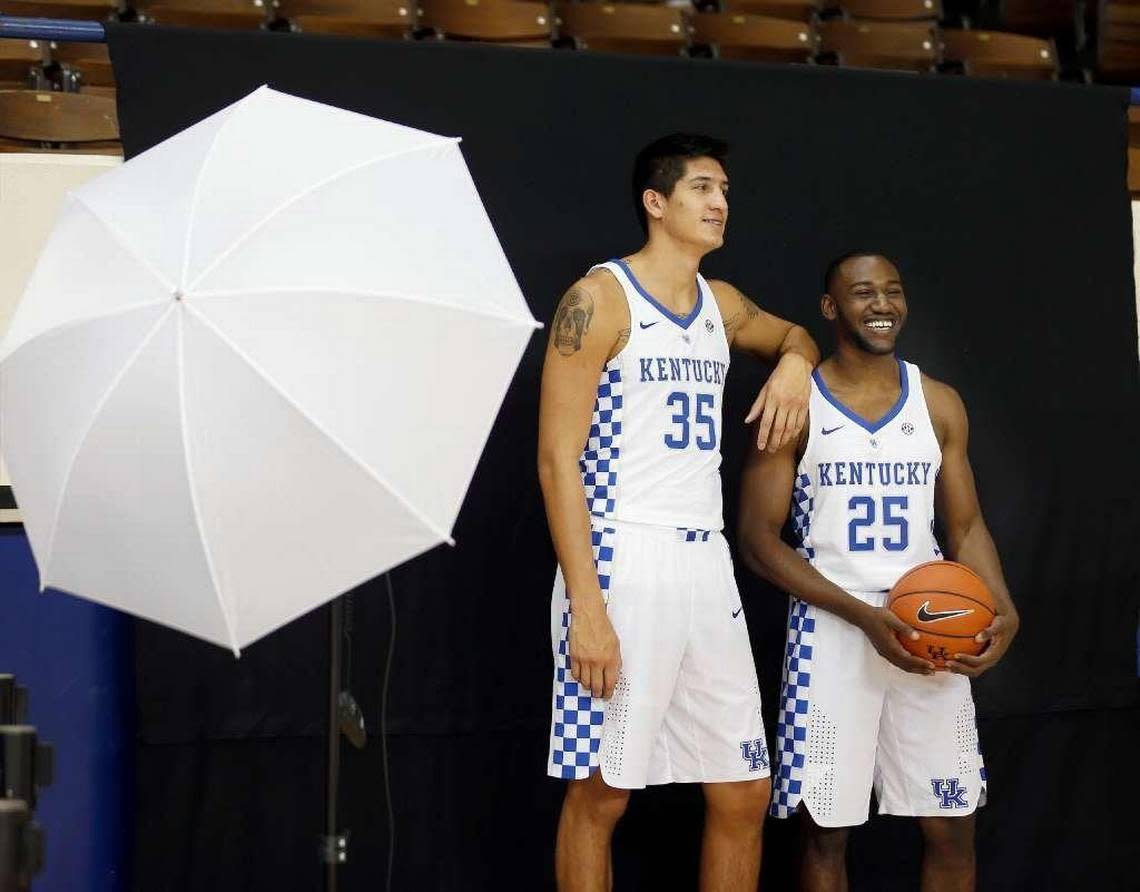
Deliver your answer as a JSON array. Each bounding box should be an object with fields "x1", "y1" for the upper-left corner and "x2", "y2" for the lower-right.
[{"x1": 0, "y1": 90, "x2": 122, "y2": 154}]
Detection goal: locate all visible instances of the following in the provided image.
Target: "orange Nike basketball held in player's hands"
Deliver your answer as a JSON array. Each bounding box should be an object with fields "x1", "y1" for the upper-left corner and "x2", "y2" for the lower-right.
[{"x1": 887, "y1": 560, "x2": 994, "y2": 668}]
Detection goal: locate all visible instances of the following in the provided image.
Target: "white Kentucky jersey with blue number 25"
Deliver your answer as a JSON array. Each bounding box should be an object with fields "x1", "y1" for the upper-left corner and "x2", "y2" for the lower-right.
[{"x1": 791, "y1": 360, "x2": 942, "y2": 593}]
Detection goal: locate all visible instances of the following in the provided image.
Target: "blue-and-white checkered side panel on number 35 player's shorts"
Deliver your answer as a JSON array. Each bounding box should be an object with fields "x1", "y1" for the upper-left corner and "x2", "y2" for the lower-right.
[{"x1": 548, "y1": 527, "x2": 614, "y2": 780}]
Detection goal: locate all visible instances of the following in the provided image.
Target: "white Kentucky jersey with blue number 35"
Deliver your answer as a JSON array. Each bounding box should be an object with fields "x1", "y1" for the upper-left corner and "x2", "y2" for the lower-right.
[{"x1": 579, "y1": 260, "x2": 728, "y2": 530}]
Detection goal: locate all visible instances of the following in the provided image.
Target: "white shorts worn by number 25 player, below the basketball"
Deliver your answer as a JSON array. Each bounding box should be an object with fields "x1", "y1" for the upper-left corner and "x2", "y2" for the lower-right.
[{"x1": 772, "y1": 592, "x2": 986, "y2": 827}]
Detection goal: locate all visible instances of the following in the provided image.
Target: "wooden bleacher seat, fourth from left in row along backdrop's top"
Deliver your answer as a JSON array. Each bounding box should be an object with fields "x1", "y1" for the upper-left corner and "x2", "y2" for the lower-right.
[{"x1": 420, "y1": 0, "x2": 553, "y2": 47}]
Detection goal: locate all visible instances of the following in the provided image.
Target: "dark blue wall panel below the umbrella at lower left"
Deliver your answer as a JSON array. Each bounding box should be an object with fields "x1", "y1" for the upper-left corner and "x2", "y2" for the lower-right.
[{"x1": 0, "y1": 527, "x2": 135, "y2": 892}]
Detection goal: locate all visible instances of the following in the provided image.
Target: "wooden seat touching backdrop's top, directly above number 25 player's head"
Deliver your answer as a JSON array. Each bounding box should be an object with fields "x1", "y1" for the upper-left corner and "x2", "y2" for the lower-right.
[{"x1": 819, "y1": 19, "x2": 941, "y2": 72}]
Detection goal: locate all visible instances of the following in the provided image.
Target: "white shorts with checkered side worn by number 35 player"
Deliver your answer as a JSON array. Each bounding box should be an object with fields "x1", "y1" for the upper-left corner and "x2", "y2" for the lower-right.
[{"x1": 547, "y1": 521, "x2": 768, "y2": 789}]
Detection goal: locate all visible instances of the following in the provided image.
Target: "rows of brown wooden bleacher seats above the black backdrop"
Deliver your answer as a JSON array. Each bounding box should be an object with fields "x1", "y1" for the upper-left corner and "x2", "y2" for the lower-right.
[{"x1": 0, "y1": 0, "x2": 1140, "y2": 188}]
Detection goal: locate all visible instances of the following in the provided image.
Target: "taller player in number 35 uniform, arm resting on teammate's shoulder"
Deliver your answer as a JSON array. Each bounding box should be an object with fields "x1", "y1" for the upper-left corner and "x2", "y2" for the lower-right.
[{"x1": 539, "y1": 135, "x2": 819, "y2": 892}]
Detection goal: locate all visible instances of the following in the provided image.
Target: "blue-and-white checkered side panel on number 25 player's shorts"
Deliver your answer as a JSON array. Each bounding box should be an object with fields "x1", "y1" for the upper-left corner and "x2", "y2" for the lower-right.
[{"x1": 772, "y1": 598, "x2": 815, "y2": 818}]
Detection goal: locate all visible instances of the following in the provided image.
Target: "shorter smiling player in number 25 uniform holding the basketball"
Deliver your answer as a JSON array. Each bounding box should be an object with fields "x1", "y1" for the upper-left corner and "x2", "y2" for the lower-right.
[{"x1": 740, "y1": 253, "x2": 1018, "y2": 892}]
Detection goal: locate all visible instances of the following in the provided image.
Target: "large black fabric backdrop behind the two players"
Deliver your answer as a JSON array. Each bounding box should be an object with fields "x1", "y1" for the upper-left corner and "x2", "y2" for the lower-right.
[{"x1": 111, "y1": 27, "x2": 1140, "y2": 892}]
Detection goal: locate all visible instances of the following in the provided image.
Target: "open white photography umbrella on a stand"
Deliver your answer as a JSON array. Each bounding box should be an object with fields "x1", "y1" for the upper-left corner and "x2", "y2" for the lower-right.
[{"x1": 0, "y1": 88, "x2": 537, "y2": 654}]
